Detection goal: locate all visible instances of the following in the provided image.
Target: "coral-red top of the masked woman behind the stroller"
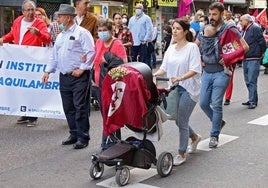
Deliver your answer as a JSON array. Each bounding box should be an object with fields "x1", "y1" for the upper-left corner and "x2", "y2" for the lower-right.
[{"x1": 94, "y1": 39, "x2": 127, "y2": 87}]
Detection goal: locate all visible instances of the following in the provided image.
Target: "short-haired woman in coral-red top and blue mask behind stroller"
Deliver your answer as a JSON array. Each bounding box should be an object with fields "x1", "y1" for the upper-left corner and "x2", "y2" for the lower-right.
[{"x1": 94, "y1": 19, "x2": 127, "y2": 149}]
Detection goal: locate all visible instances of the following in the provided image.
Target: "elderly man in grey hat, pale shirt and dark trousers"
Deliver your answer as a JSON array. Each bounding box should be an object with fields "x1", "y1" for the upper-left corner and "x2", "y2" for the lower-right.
[{"x1": 42, "y1": 4, "x2": 95, "y2": 149}]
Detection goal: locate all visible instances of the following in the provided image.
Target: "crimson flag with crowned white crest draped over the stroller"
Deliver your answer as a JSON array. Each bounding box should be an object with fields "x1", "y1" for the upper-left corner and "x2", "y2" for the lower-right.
[{"x1": 102, "y1": 66, "x2": 151, "y2": 136}]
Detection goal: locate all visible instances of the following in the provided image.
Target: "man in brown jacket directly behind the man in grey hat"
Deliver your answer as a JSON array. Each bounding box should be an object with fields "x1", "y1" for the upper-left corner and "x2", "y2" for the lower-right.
[{"x1": 73, "y1": 0, "x2": 98, "y2": 43}]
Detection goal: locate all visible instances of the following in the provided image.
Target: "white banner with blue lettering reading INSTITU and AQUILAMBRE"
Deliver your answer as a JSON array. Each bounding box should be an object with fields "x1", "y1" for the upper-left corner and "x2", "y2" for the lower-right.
[{"x1": 0, "y1": 44, "x2": 65, "y2": 119}]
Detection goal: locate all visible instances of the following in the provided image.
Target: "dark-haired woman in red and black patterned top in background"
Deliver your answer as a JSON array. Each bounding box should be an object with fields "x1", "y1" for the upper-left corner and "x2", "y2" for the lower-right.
[{"x1": 113, "y1": 13, "x2": 133, "y2": 62}]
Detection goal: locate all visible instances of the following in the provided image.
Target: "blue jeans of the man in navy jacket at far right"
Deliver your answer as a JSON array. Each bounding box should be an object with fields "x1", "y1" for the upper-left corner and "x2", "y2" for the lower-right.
[{"x1": 243, "y1": 60, "x2": 260, "y2": 104}]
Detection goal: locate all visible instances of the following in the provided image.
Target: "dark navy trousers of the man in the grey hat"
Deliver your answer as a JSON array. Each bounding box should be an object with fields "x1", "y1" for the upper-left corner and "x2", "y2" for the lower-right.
[{"x1": 60, "y1": 71, "x2": 90, "y2": 142}]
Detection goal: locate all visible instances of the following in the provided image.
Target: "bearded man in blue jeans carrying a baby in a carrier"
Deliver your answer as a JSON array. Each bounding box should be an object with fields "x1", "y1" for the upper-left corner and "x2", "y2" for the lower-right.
[{"x1": 195, "y1": 2, "x2": 247, "y2": 148}]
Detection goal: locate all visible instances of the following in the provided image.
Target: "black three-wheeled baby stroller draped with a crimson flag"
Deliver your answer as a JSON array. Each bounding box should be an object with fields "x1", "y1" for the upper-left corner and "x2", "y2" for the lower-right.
[{"x1": 90, "y1": 62, "x2": 173, "y2": 186}]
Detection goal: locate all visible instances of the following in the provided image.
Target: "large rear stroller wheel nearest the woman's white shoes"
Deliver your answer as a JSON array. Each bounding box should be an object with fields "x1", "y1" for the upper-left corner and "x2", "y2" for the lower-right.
[{"x1": 156, "y1": 152, "x2": 173, "y2": 177}]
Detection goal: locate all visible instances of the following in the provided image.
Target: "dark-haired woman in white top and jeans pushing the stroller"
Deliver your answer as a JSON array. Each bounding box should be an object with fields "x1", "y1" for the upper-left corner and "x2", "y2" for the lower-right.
[{"x1": 153, "y1": 19, "x2": 202, "y2": 165}]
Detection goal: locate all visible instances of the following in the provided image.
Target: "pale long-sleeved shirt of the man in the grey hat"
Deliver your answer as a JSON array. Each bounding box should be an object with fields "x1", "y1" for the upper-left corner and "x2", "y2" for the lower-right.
[{"x1": 46, "y1": 24, "x2": 95, "y2": 74}]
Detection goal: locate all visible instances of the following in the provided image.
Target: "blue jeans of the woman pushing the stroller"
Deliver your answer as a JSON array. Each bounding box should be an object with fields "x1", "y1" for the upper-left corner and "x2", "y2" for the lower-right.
[{"x1": 176, "y1": 86, "x2": 196, "y2": 153}]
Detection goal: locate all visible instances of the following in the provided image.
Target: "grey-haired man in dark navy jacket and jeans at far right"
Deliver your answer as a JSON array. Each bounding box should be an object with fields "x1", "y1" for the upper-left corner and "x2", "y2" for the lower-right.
[{"x1": 240, "y1": 14, "x2": 266, "y2": 109}]
